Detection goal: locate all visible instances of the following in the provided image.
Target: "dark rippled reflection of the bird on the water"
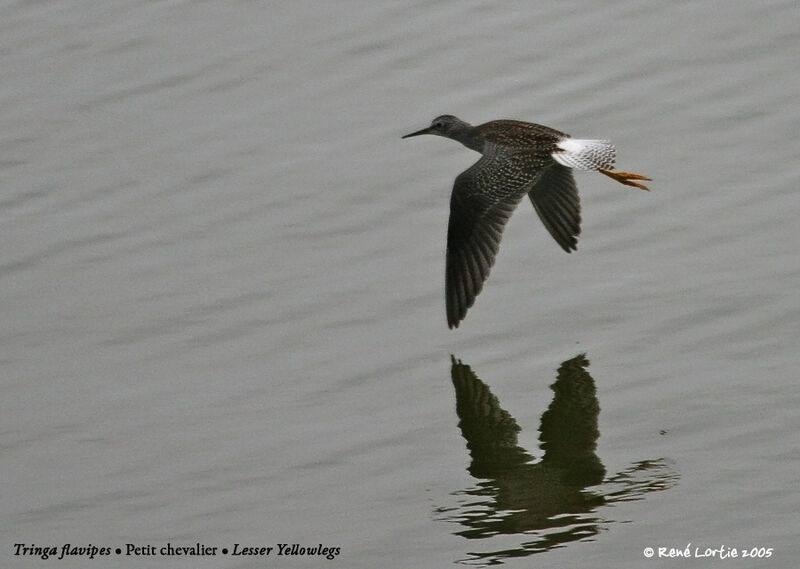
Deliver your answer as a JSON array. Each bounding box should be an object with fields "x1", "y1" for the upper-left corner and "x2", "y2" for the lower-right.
[{"x1": 438, "y1": 355, "x2": 677, "y2": 563}]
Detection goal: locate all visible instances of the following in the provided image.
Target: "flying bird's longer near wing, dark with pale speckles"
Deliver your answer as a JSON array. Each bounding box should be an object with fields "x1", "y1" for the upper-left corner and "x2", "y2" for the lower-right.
[{"x1": 445, "y1": 144, "x2": 552, "y2": 328}]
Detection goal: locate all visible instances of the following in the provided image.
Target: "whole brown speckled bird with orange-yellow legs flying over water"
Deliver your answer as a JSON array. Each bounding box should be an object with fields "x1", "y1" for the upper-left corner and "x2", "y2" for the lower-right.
[{"x1": 402, "y1": 115, "x2": 651, "y2": 329}]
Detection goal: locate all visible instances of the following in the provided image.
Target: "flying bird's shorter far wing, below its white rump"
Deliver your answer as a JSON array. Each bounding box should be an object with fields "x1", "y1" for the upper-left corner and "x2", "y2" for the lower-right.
[{"x1": 528, "y1": 164, "x2": 581, "y2": 253}]
